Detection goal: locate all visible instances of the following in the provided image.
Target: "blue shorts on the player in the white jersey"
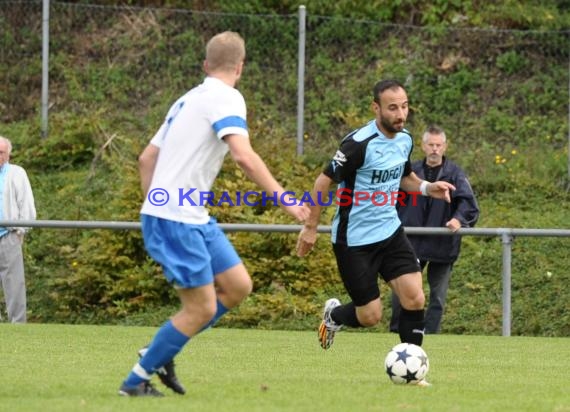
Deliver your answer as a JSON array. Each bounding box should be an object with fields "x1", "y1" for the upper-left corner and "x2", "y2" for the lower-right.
[{"x1": 141, "y1": 214, "x2": 241, "y2": 289}]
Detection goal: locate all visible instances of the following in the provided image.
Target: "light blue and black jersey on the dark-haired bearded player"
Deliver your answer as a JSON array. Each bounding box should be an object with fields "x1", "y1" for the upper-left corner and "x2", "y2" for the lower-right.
[{"x1": 323, "y1": 120, "x2": 413, "y2": 246}]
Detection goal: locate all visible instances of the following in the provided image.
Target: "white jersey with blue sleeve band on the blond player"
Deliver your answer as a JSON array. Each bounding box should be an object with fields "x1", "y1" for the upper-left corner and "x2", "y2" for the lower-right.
[{"x1": 141, "y1": 77, "x2": 249, "y2": 224}]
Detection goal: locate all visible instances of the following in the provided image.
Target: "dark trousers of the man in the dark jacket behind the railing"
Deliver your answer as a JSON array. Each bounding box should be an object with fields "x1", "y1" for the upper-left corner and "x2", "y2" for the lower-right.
[{"x1": 390, "y1": 260, "x2": 453, "y2": 333}]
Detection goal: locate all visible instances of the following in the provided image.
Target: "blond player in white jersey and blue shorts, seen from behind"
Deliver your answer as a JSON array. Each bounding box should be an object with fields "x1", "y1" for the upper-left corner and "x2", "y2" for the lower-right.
[{"x1": 119, "y1": 32, "x2": 309, "y2": 396}]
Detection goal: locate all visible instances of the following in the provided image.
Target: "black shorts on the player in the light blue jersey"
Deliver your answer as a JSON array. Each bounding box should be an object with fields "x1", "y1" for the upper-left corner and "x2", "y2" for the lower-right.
[{"x1": 333, "y1": 227, "x2": 421, "y2": 306}]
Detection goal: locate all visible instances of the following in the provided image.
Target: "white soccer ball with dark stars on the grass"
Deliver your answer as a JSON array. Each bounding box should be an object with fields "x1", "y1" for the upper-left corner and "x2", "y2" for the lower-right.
[{"x1": 384, "y1": 343, "x2": 429, "y2": 384}]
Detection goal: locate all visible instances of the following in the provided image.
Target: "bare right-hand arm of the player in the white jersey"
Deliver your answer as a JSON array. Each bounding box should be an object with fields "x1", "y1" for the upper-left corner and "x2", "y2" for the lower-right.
[{"x1": 224, "y1": 135, "x2": 309, "y2": 222}]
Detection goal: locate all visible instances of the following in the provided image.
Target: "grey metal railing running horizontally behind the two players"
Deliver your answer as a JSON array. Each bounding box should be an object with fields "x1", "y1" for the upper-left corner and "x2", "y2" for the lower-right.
[{"x1": 0, "y1": 220, "x2": 570, "y2": 336}]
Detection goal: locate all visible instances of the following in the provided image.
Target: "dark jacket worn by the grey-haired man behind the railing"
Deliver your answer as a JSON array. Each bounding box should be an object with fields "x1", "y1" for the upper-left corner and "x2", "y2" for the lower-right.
[{"x1": 398, "y1": 157, "x2": 479, "y2": 263}]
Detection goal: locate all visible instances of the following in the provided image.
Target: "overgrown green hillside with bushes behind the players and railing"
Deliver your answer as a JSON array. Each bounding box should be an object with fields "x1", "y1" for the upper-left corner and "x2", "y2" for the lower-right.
[{"x1": 0, "y1": 0, "x2": 570, "y2": 336}]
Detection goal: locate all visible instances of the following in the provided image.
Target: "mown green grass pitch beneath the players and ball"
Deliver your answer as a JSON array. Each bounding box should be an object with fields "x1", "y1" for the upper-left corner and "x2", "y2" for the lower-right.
[{"x1": 0, "y1": 323, "x2": 570, "y2": 412}]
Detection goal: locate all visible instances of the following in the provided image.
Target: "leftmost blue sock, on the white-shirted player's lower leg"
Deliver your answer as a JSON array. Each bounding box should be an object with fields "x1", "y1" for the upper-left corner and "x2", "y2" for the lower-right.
[{"x1": 125, "y1": 320, "x2": 190, "y2": 387}]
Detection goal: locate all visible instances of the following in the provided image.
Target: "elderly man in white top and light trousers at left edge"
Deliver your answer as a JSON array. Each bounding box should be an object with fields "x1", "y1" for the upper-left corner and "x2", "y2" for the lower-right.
[{"x1": 0, "y1": 136, "x2": 36, "y2": 323}]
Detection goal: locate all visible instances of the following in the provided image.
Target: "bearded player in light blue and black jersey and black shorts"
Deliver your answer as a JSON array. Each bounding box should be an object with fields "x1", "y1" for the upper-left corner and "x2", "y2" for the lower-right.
[{"x1": 297, "y1": 80, "x2": 455, "y2": 386}]
